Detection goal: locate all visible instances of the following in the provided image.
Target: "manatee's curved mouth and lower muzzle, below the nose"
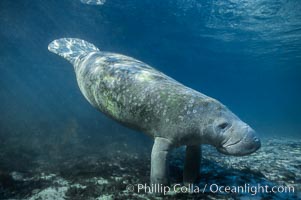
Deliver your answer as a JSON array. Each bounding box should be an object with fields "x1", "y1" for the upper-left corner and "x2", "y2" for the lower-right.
[{"x1": 217, "y1": 130, "x2": 261, "y2": 156}]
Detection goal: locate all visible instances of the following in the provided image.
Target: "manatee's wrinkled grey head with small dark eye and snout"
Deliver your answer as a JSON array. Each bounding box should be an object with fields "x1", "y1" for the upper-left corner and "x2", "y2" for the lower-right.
[{"x1": 199, "y1": 101, "x2": 261, "y2": 156}]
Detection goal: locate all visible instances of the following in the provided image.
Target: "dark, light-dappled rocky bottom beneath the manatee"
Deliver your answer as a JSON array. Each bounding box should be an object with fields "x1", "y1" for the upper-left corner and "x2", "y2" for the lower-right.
[{"x1": 0, "y1": 138, "x2": 301, "y2": 200}]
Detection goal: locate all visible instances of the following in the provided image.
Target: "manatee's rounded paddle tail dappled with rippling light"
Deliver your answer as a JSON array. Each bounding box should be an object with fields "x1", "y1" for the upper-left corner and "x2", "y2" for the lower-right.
[{"x1": 48, "y1": 38, "x2": 99, "y2": 64}]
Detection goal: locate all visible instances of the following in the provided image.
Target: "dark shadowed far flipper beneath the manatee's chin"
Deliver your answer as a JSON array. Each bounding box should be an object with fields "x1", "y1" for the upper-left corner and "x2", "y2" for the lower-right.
[{"x1": 183, "y1": 145, "x2": 202, "y2": 183}]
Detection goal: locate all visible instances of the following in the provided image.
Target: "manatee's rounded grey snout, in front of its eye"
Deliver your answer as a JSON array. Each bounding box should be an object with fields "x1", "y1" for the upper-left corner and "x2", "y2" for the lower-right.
[{"x1": 217, "y1": 125, "x2": 261, "y2": 156}]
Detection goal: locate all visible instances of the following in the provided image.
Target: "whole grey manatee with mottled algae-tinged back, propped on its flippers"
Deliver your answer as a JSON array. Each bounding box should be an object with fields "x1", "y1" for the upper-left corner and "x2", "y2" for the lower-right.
[{"x1": 48, "y1": 38, "x2": 261, "y2": 185}]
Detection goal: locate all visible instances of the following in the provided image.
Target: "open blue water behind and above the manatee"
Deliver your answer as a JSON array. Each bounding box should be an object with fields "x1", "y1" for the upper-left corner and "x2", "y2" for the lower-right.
[{"x1": 0, "y1": 0, "x2": 301, "y2": 198}]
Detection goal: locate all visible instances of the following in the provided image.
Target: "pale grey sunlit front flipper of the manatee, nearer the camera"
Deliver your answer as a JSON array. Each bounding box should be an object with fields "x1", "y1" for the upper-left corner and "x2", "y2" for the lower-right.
[{"x1": 151, "y1": 137, "x2": 172, "y2": 185}]
